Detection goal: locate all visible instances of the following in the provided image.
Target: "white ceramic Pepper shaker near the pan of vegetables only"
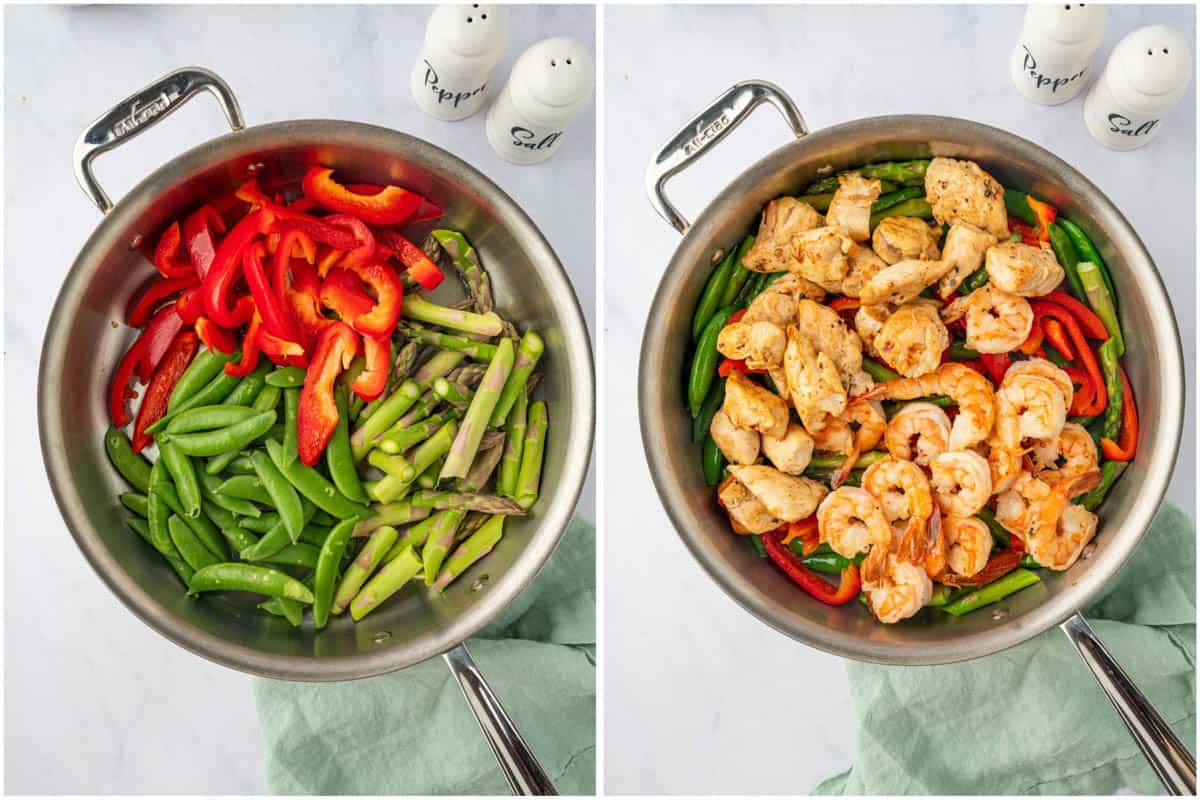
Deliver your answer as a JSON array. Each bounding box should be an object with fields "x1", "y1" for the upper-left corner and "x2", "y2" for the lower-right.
[{"x1": 409, "y1": 2, "x2": 509, "y2": 121}]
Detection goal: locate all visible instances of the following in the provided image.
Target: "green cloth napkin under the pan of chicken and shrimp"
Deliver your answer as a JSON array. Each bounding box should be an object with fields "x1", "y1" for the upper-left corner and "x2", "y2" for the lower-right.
[{"x1": 816, "y1": 504, "x2": 1196, "y2": 795}]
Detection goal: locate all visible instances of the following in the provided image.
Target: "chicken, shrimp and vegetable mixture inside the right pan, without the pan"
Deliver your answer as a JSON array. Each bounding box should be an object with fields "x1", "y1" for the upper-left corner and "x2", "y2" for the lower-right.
[{"x1": 688, "y1": 157, "x2": 1138, "y2": 622}]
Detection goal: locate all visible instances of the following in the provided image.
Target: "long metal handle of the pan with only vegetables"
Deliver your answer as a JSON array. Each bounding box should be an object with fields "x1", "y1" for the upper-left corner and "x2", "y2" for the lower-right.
[{"x1": 443, "y1": 644, "x2": 558, "y2": 795}]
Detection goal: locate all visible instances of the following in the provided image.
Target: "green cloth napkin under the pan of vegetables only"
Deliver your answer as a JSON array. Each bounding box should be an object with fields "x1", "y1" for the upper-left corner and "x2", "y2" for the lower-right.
[{"x1": 256, "y1": 519, "x2": 596, "y2": 795}]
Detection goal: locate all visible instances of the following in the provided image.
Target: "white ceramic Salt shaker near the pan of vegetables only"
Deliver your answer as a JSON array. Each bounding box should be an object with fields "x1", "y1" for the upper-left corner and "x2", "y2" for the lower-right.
[{"x1": 487, "y1": 36, "x2": 595, "y2": 164}]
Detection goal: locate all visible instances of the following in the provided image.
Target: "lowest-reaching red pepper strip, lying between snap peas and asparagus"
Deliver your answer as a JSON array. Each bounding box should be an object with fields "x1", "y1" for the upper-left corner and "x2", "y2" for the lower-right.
[{"x1": 296, "y1": 321, "x2": 359, "y2": 467}]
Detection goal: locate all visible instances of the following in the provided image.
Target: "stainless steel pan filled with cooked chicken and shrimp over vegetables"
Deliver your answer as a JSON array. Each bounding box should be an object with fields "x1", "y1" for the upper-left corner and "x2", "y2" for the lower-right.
[{"x1": 640, "y1": 83, "x2": 1194, "y2": 796}]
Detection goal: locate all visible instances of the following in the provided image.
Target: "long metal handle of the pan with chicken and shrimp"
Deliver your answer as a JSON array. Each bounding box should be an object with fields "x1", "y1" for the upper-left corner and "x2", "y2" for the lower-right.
[{"x1": 1062, "y1": 614, "x2": 1196, "y2": 795}]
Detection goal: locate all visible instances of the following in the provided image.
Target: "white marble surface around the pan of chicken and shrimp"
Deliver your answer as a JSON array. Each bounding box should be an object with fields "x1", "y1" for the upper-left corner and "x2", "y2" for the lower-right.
[{"x1": 602, "y1": 5, "x2": 1196, "y2": 794}]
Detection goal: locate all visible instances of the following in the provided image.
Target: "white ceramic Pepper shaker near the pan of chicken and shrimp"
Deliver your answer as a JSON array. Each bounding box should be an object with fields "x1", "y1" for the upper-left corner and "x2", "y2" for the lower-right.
[{"x1": 1009, "y1": 2, "x2": 1108, "y2": 106}]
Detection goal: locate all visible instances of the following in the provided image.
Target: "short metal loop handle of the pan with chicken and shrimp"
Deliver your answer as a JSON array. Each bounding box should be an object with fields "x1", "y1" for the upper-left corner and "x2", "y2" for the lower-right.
[{"x1": 646, "y1": 80, "x2": 809, "y2": 234}]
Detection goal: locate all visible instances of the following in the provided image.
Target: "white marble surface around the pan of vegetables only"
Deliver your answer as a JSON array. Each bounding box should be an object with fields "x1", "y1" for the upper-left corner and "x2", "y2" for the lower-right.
[{"x1": 5, "y1": 6, "x2": 595, "y2": 794}]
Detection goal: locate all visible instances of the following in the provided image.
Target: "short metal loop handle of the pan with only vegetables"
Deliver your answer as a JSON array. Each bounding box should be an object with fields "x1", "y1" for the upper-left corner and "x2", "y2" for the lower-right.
[{"x1": 74, "y1": 67, "x2": 246, "y2": 213}]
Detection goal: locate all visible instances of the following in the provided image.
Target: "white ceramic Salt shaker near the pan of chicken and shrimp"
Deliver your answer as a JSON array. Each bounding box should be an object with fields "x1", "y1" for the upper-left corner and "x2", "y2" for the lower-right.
[{"x1": 1084, "y1": 25, "x2": 1192, "y2": 150}]
